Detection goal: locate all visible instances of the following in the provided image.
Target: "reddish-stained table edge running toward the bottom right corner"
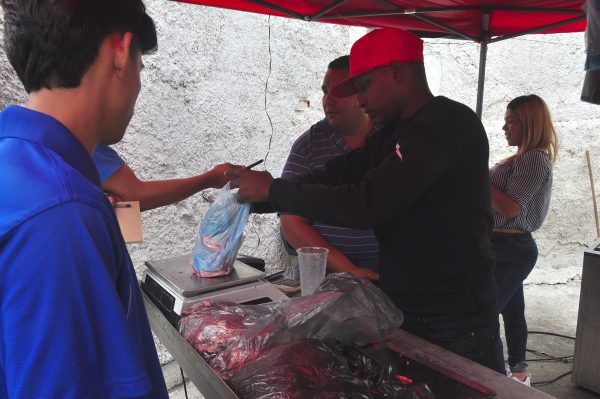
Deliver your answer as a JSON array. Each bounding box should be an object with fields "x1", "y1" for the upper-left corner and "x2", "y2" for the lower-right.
[{"x1": 386, "y1": 330, "x2": 553, "y2": 399}]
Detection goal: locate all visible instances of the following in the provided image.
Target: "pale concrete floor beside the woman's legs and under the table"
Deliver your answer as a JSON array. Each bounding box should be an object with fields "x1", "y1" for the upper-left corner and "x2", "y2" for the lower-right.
[{"x1": 169, "y1": 278, "x2": 600, "y2": 399}]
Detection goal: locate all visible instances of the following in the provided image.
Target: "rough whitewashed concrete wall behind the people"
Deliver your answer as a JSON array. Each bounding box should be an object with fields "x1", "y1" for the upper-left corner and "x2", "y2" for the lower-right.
[{"x1": 0, "y1": 0, "x2": 600, "y2": 378}]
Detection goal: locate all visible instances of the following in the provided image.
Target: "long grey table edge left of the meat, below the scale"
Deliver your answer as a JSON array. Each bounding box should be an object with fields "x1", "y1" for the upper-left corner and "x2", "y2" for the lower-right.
[{"x1": 142, "y1": 291, "x2": 238, "y2": 399}]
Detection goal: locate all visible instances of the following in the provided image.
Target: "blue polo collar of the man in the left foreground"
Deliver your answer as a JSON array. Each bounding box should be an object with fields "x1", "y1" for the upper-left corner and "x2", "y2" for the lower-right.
[{"x1": 0, "y1": 105, "x2": 101, "y2": 187}]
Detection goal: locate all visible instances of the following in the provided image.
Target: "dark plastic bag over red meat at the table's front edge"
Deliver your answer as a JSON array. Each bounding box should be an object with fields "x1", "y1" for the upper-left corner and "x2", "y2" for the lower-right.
[{"x1": 230, "y1": 339, "x2": 434, "y2": 399}]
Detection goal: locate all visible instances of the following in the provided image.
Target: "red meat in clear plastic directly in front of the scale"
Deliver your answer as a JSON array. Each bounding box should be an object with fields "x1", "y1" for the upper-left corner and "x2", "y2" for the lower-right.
[{"x1": 179, "y1": 300, "x2": 286, "y2": 380}]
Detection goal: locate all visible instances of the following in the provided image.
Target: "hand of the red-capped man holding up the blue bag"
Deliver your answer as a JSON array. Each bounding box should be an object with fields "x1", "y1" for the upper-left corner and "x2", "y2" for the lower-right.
[{"x1": 225, "y1": 167, "x2": 273, "y2": 202}]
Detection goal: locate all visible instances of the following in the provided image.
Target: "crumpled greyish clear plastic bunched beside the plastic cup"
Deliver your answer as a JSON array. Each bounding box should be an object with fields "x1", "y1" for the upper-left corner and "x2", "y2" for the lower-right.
[{"x1": 282, "y1": 273, "x2": 404, "y2": 345}]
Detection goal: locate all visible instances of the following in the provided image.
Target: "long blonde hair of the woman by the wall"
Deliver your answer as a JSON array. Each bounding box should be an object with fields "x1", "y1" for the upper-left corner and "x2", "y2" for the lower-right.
[{"x1": 502, "y1": 94, "x2": 559, "y2": 164}]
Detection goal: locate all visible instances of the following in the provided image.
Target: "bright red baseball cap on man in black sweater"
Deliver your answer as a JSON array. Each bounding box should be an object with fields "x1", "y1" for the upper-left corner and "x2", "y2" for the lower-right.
[{"x1": 331, "y1": 28, "x2": 423, "y2": 97}]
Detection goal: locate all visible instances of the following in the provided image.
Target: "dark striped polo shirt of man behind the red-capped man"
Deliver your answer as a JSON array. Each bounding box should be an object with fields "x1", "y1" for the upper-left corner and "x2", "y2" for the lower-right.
[{"x1": 281, "y1": 119, "x2": 379, "y2": 264}]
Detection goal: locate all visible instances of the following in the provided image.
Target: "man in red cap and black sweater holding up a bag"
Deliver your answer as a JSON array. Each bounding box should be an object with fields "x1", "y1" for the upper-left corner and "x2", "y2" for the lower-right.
[{"x1": 229, "y1": 29, "x2": 504, "y2": 372}]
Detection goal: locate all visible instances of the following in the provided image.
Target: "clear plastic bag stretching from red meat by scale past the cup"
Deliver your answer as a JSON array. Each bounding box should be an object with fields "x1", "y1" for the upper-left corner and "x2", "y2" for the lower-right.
[{"x1": 180, "y1": 273, "x2": 402, "y2": 380}]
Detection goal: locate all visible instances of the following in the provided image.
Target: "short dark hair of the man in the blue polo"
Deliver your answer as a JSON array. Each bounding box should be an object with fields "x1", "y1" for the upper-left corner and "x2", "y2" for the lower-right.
[{"x1": 1, "y1": 0, "x2": 157, "y2": 93}]
